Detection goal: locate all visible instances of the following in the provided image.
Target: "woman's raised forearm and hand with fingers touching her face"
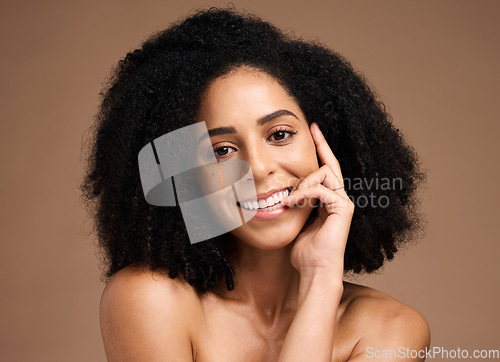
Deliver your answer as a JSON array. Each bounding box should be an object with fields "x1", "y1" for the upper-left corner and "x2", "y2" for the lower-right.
[{"x1": 279, "y1": 124, "x2": 354, "y2": 362}]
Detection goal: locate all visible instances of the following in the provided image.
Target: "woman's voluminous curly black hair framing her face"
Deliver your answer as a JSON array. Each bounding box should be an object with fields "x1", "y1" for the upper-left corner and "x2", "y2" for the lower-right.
[{"x1": 80, "y1": 8, "x2": 425, "y2": 293}]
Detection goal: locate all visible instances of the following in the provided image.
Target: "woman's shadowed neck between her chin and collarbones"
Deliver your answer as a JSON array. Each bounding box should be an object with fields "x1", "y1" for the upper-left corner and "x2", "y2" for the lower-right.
[{"x1": 217, "y1": 242, "x2": 299, "y2": 323}]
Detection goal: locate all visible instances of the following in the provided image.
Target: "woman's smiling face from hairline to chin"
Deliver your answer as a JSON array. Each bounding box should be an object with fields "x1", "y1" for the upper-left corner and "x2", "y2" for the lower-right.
[{"x1": 197, "y1": 67, "x2": 319, "y2": 250}]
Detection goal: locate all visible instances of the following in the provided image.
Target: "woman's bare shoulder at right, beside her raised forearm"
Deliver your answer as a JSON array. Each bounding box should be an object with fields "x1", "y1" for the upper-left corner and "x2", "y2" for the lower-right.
[{"x1": 343, "y1": 283, "x2": 430, "y2": 361}]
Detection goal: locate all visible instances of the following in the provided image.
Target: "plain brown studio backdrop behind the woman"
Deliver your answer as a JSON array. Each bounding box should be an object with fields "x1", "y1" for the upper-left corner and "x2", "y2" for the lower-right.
[{"x1": 0, "y1": 0, "x2": 500, "y2": 361}]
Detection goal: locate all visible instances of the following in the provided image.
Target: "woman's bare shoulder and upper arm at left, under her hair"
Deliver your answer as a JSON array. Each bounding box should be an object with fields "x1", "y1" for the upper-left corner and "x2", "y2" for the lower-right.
[{"x1": 100, "y1": 266, "x2": 197, "y2": 361}]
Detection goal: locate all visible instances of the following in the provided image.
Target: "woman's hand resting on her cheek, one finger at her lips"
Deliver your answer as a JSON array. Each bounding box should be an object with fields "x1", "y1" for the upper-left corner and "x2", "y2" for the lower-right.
[{"x1": 283, "y1": 123, "x2": 354, "y2": 278}]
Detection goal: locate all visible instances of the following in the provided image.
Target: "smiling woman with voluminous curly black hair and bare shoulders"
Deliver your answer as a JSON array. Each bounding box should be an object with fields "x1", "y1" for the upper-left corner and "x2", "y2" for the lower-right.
[{"x1": 82, "y1": 9, "x2": 429, "y2": 361}]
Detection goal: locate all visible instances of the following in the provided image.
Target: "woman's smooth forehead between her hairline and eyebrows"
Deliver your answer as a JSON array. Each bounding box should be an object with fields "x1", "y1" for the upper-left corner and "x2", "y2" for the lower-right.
[{"x1": 198, "y1": 67, "x2": 302, "y2": 124}]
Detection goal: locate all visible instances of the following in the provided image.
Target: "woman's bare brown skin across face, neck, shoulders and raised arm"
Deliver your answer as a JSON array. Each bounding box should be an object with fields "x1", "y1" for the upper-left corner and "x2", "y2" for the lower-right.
[{"x1": 101, "y1": 67, "x2": 430, "y2": 362}]
